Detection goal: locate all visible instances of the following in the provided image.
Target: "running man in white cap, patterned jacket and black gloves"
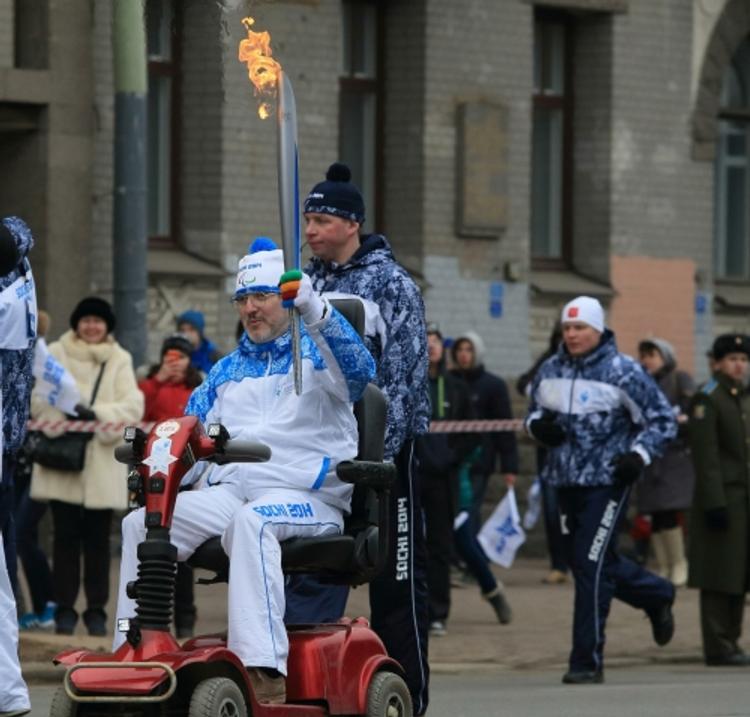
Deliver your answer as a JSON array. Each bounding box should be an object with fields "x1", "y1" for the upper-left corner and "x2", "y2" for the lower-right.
[{"x1": 526, "y1": 296, "x2": 677, "y2": 684}]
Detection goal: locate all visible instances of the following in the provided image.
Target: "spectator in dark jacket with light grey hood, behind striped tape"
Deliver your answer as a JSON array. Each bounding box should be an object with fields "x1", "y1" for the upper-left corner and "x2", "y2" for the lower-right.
[{"x1": 451, "y1": 331, "x2": 518, "y2": 532}]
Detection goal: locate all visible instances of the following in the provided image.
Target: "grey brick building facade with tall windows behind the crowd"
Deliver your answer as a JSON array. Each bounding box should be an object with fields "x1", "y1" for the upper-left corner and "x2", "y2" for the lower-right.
[{"x1": 0, "y1": 0, "x2": 750, "y2": 376}]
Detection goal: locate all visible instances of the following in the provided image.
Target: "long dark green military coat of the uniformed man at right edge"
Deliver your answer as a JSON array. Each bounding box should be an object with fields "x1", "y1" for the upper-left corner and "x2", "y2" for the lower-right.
[{"x1": 688, "y1": 373, "x2": 750, "y2": 595}]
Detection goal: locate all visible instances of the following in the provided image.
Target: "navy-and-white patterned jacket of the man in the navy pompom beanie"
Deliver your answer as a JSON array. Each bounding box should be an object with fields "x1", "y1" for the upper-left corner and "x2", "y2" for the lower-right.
[{"x1": 305, "y1": 234, "x2": 430, "y2": 460}]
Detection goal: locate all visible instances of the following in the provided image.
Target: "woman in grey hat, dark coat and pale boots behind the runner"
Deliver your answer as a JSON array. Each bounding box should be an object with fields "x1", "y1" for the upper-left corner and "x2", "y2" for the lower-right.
[{"x1": 636, "y1": 338, "x2": 695, "y2": 587}]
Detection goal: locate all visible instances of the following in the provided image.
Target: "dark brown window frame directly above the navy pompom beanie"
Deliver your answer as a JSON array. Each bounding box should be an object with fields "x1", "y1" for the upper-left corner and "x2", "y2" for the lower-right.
[{"x1": 337, "y1": 0, "x2": 386, "y2": 231}]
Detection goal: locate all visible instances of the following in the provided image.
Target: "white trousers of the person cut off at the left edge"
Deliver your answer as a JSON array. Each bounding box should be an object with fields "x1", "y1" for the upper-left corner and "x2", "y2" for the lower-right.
[{"x1": 0, "y1": 533, "x2": 31, "y2": 712}]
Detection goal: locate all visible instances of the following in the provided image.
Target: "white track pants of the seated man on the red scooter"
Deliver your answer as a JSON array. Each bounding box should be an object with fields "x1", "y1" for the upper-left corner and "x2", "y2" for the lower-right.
[{"x1": 113, "y1": 485, "x2": 343, "y2": 674}]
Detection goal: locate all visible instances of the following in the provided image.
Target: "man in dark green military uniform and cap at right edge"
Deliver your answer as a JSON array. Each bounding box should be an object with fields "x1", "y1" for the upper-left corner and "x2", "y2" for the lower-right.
[{"x1": 688, "y1": 334, "x2": 750, "y2": 667}]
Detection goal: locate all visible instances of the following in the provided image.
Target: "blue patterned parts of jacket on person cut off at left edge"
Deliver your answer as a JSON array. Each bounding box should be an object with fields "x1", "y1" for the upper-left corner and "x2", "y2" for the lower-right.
[{"x1": 0, "y1": 217, "x2": 34, "y2": 455}]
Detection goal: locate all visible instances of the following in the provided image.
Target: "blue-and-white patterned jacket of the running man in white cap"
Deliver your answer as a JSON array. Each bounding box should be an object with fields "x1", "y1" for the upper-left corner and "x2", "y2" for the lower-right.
[{"x1": 526, "y1": 329, "x2": 677, "y2": 486}]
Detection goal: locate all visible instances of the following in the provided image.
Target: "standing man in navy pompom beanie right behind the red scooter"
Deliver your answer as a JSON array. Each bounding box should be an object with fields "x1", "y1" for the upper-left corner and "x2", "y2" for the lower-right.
[{"x1": 287, "y1": 163, "x2": 430, "y2": 715}]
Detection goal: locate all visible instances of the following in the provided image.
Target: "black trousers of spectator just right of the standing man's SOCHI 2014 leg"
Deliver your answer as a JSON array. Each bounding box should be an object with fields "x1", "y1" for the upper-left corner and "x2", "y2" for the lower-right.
[{"x1": 420, "y1": 473, "x2": 456, "y2": 622}]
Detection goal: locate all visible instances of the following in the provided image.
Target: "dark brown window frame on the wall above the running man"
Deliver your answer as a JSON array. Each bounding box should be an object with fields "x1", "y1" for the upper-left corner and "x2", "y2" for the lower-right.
[{"x1": 529, "y1": 8, "x2": 575, "y2": 270}]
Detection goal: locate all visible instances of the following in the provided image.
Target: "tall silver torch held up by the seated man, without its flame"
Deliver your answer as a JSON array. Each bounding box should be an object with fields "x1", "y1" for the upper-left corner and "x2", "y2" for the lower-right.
[{"x1": 276, "y1": 70, "x2": 302, "y2": 396}]
